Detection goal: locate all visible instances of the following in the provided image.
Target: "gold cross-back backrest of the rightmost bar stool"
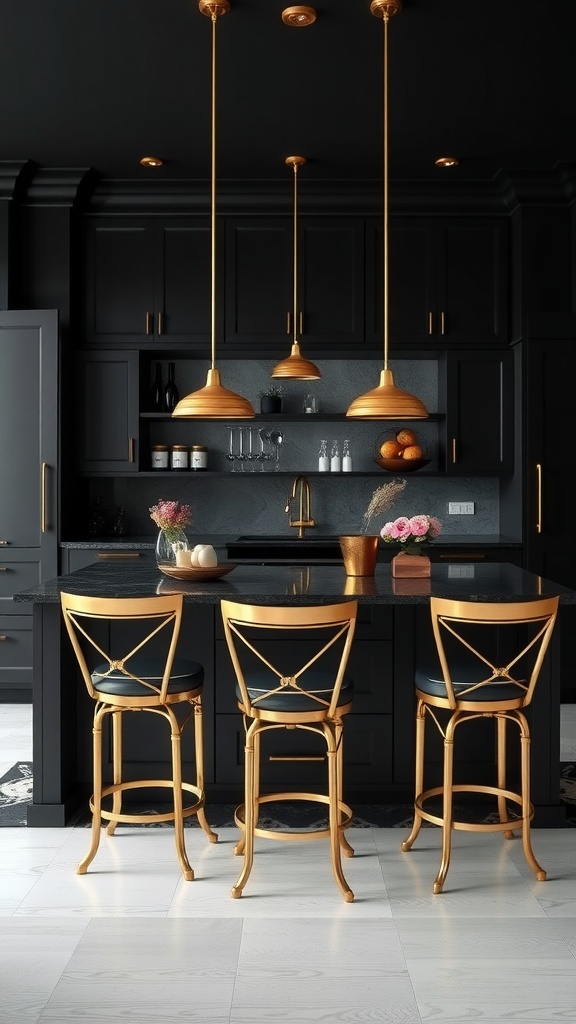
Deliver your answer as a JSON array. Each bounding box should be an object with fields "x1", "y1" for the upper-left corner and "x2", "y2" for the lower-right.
[{"x1": 430, "y1": 597, "x2": 559, "y2": 708}]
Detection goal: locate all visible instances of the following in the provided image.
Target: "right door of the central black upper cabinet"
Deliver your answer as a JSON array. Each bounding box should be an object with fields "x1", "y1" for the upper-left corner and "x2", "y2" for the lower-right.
[{"x1": 292, "y1": 217, "x2": 364, "y2": 348}]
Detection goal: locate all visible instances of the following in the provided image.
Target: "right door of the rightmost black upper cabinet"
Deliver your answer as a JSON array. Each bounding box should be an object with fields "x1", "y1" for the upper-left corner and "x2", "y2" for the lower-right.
[{"x1": 435, "y1": 217, "x2": 507, "y2": 345}]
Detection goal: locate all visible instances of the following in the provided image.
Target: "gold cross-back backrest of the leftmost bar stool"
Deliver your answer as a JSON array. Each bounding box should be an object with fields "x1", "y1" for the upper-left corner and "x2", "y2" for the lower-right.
[{"x1": 60, "y1": 593, "x2": 183, "y2": 703}]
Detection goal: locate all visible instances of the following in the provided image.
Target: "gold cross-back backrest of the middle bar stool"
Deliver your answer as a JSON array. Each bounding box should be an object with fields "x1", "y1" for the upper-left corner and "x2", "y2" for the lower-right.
[{"x1": 221, "y1": 601, "x2": 358, "y2": 718}]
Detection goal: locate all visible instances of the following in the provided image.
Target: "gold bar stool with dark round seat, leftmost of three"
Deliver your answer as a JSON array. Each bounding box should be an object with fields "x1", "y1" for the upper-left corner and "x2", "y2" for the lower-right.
[{"x1": 60, "y1": 594, "x2": 218, "y2": 882}]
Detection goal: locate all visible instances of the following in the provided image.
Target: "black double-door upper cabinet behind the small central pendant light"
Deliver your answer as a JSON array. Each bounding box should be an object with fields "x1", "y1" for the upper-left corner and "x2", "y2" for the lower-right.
[{"x1": 223, "y1": 216, "x2": 364, "y2": 358}]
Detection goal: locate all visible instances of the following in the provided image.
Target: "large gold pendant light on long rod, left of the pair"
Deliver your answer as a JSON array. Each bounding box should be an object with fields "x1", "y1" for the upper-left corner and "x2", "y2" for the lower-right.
[{"x1": 172, "y1": 0, "x2": 251, "y2": 420}]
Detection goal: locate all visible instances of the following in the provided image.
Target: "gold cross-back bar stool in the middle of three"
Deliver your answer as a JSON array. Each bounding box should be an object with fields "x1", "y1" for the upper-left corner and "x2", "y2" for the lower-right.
[{"x1": 221, "y1": 601, "x2": 358, "y2": 903}]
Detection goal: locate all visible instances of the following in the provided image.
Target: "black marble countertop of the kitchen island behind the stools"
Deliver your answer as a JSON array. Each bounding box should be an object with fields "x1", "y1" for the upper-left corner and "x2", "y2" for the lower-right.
[{"x1": 13, "y1": 562, "x2": 576, "y2": 605}]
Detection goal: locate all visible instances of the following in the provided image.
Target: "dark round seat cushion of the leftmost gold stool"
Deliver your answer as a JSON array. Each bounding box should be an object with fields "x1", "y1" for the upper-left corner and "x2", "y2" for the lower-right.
[{"x1": 92, "y1": 655, "x2": 204, "y2": 697}]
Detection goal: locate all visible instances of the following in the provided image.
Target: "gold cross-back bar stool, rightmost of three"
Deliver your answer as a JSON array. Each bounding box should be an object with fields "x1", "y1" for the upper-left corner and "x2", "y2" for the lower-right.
[{"x1": 402, "y1": 597, "x2": 559, "y2": 893}]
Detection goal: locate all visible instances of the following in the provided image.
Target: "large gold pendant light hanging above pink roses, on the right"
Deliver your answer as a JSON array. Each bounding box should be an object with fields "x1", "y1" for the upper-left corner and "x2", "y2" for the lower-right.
[{"x1": 346, "y1": 0, "x2": 428, "y2": 420}]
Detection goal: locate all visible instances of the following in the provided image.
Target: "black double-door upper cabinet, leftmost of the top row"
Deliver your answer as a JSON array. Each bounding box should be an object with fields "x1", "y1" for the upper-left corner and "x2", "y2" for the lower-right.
[{"x1": 84, "y1": 217, "x2": 210, "y2": 351}]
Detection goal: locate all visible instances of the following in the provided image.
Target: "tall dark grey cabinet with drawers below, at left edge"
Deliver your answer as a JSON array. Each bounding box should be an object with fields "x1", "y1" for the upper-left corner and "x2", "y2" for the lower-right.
[{"x1": 0, "y1": 309, "x2": 58, "y2": 701}]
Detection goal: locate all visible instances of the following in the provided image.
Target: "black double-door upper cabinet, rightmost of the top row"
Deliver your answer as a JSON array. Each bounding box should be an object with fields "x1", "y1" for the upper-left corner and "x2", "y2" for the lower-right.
[{"x1": 366, "y1": 216, "x2": 508, "y2": 356}]
